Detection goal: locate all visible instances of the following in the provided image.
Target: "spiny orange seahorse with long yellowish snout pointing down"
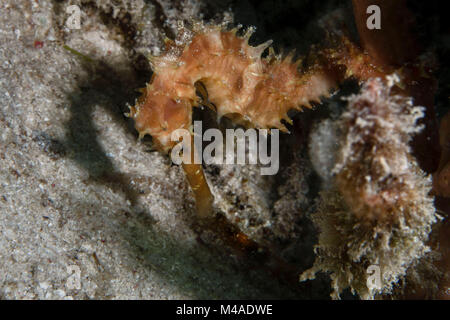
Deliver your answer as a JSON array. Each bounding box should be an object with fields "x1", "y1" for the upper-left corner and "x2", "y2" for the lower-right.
[{"x1": 129, "y1": 23, "x2": 336, "y2": 215}]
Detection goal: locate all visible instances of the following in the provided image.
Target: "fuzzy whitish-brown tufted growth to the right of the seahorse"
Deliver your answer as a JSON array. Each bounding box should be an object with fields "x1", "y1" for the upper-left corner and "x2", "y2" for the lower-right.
[{"x1": 301, "y1": 78, "x2": 436, "y2": 299}]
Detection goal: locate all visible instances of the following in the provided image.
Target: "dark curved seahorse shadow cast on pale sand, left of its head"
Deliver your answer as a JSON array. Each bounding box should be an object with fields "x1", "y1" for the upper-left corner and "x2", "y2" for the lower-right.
[{"x1": 64, "y1": 56, "x2": 150, "y2": 205}]
